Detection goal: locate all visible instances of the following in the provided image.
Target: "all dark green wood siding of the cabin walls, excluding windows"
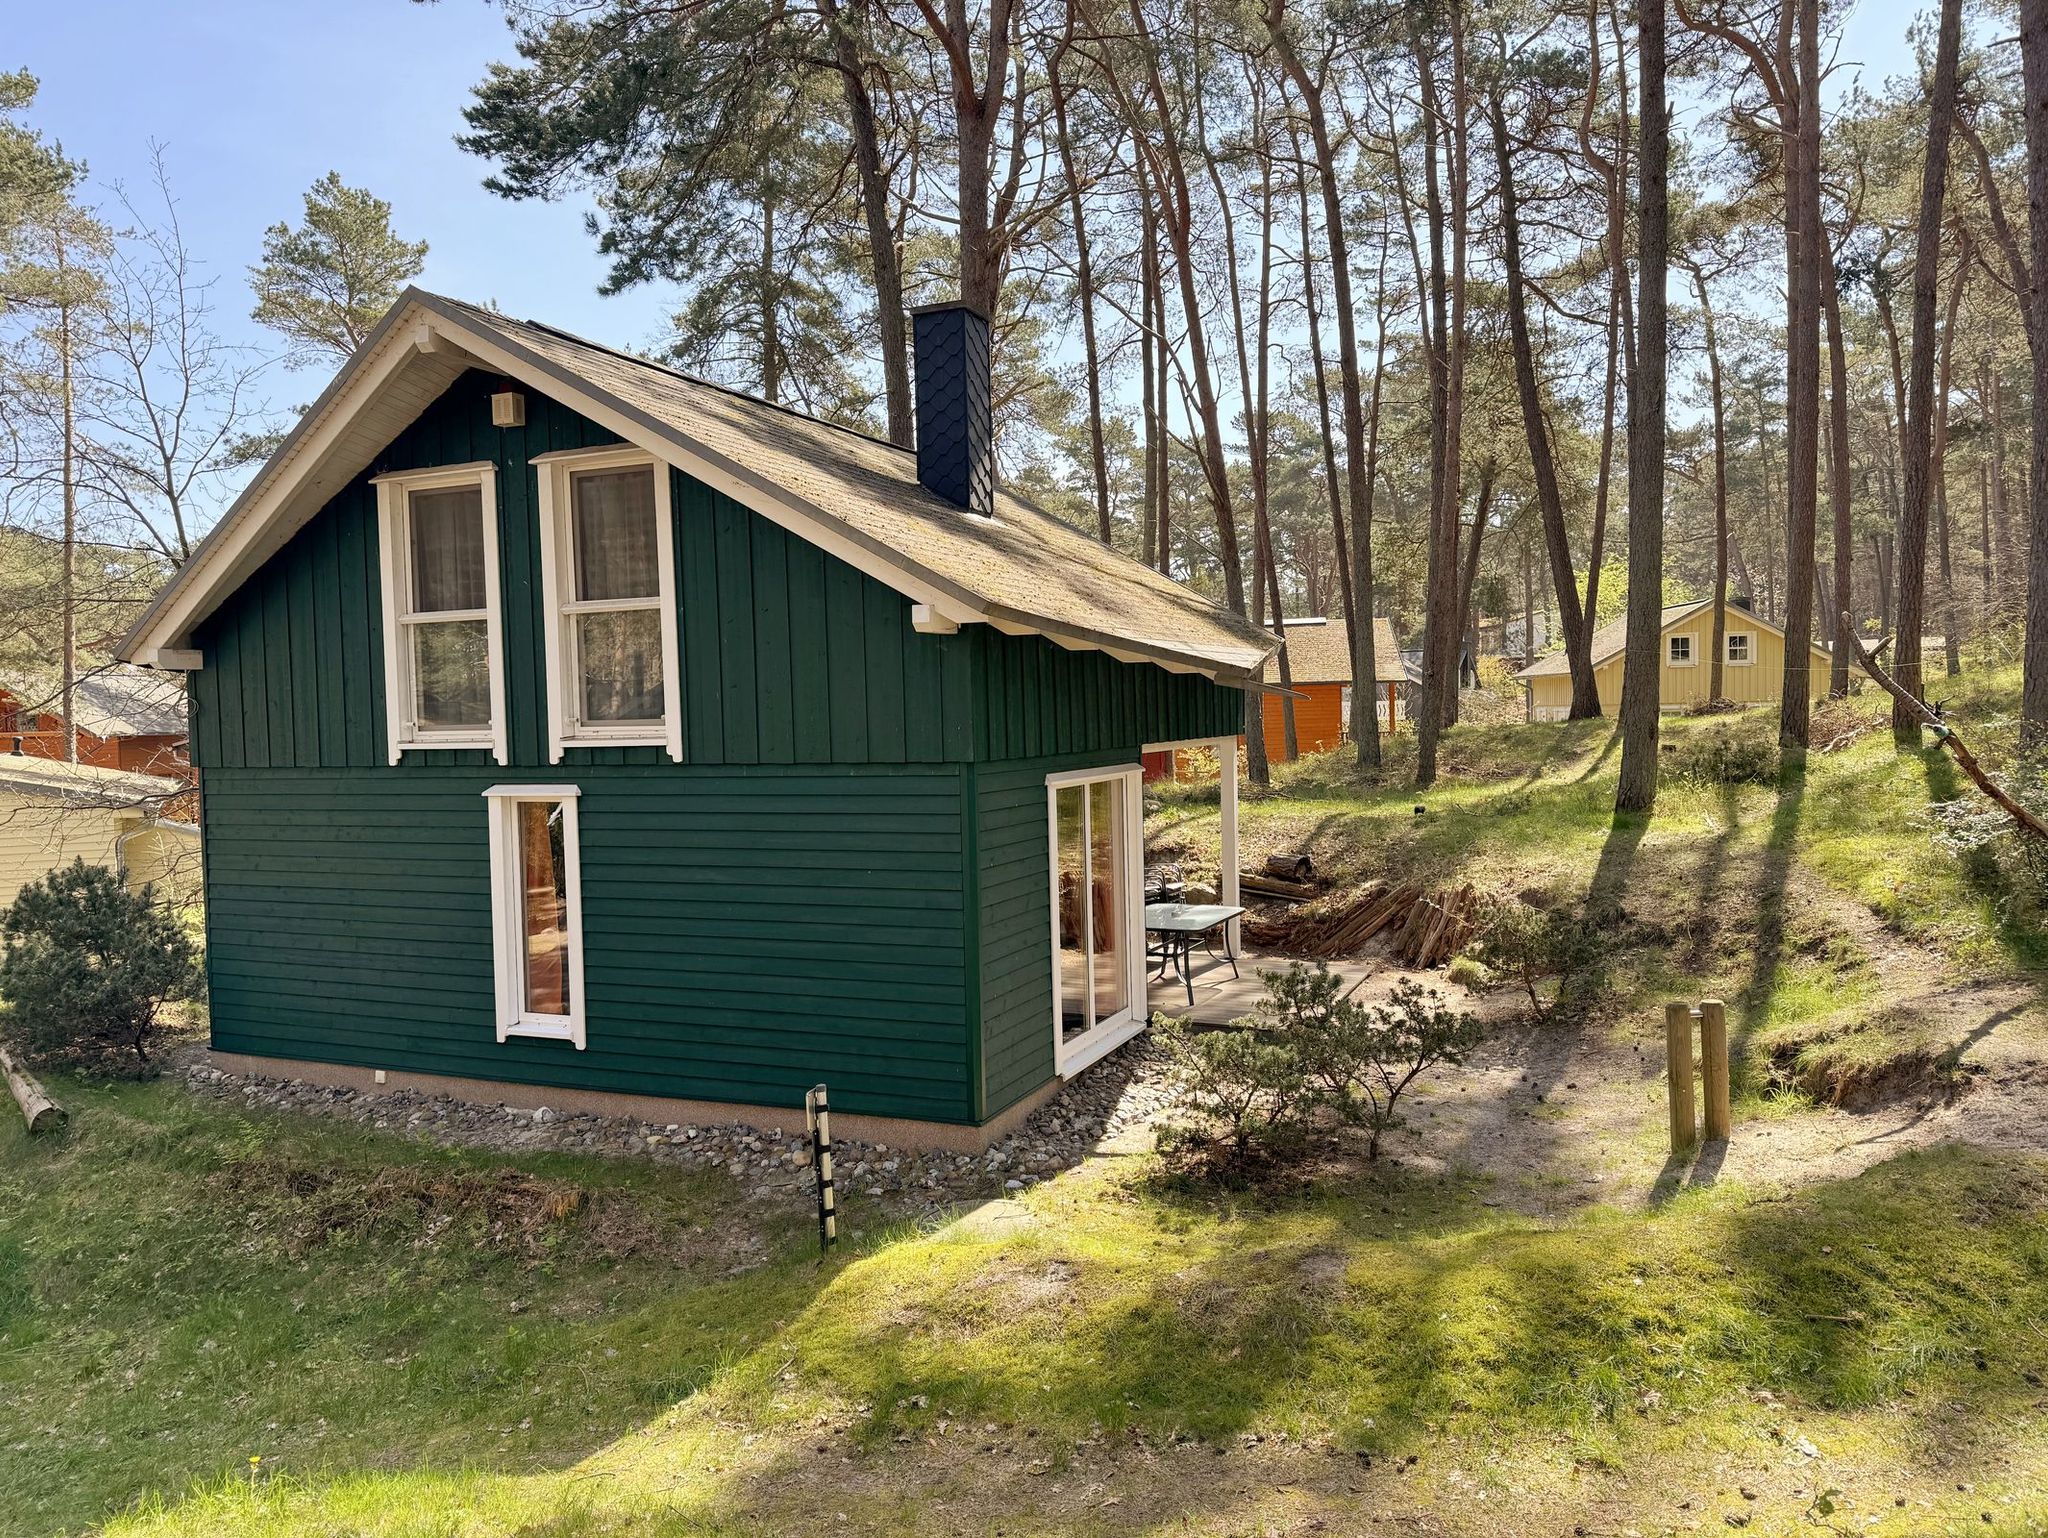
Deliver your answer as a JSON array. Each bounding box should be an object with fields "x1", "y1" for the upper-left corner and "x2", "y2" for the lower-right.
[{"x1": 190, "y1": 373, "x2": 1243, "y2": 1120}]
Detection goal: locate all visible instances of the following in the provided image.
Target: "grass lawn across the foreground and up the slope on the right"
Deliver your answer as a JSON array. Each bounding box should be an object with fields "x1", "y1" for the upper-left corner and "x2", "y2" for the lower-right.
[{"x1": 0, "y1": 678, "x2": 2048, "y2": 1538}]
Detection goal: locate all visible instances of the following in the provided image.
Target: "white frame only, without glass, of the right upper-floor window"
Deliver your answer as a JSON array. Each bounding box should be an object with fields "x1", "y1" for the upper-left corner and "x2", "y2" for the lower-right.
[{"x1": 530, "y1": 444, "x2": 682, "y2": 764}]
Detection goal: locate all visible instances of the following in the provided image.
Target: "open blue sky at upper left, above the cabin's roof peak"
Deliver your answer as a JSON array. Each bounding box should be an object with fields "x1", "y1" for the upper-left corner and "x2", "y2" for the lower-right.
[{"x1": 16, "y1": 0, "x2": 672, "y2": 354}]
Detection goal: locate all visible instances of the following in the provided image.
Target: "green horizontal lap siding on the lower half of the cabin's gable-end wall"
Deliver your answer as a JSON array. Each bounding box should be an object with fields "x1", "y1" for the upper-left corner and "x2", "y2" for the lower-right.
[{"x1": 205, "y1": 768, "x2": 971, "y2": 1120}]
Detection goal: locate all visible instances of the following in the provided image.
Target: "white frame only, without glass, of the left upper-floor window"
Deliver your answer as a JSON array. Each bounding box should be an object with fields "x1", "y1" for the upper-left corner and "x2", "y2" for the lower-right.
[{"x1": 371, "y1": 459, "x2": 510, "y2": 764}]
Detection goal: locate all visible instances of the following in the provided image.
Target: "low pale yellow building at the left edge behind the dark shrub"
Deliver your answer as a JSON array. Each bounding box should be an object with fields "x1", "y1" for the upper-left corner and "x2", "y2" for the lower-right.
[{"x1": 0, "y1": 754, "x2": 201, "y2": 907}]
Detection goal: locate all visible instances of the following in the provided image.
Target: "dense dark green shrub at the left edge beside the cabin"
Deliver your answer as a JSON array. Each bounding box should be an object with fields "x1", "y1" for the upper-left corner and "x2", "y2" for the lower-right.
[{"x1": 0, "y1": 860, "x2": 201, "y2": 1073}]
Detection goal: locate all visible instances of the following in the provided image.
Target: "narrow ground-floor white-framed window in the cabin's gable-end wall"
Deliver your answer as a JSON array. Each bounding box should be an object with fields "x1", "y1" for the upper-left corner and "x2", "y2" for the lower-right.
[{"x1": 483, "y1": 784, "x2": 584, "y2": 1051}]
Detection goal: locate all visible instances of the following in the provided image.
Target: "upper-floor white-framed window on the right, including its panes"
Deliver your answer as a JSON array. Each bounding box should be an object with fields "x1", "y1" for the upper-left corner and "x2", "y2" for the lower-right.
[{"x1": 532, "y1": 448, "x2": 682, "y2": 764}]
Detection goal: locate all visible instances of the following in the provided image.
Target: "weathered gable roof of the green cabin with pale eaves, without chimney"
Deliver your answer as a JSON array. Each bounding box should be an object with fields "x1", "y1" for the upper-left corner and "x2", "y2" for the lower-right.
[{"x1": 119, "y1": 289, "x2": 1276, "y2": 684}]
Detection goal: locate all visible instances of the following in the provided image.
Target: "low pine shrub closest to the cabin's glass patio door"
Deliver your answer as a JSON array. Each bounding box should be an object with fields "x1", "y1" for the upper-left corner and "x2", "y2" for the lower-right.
[{"x1": 1153, "y1": 1016, "x2": 1311, "y2": 1163}]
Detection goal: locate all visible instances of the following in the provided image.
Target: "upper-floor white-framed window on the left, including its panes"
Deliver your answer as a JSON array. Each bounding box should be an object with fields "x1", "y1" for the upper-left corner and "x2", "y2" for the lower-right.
[{"x1": 373, "y1": 463, "x2": 506, "y2": 764}]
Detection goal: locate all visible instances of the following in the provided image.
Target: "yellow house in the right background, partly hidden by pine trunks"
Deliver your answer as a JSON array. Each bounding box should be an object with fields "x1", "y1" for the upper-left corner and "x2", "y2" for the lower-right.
[{"x1": 1516, "y1": 598, "x2": 1829, "y2": 721}]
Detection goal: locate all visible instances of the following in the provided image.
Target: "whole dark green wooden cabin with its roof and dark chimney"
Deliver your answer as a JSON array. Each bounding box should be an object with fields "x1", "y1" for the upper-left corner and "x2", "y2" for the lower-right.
[{"x1": 123, "y1": 291, "x2": 1270, "y2": 1128}]
